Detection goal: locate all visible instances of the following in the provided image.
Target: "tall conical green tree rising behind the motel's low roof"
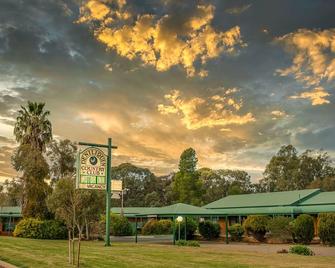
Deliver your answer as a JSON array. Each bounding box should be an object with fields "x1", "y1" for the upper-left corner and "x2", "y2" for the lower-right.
[{"x1": 172, "y1": 148, "x2": 203, "y2": 205}]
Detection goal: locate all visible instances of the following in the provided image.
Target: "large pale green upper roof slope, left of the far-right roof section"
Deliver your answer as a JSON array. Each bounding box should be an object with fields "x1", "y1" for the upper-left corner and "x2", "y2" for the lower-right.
[{"x1": 204, "y1": 189, "x2": 320, "y2": 209}]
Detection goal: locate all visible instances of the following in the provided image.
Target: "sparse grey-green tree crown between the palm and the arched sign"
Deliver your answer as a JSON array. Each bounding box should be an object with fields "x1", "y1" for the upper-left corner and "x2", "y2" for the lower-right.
[{"x1": 47, "y1": 140, "x2": 77, "y2": 183}]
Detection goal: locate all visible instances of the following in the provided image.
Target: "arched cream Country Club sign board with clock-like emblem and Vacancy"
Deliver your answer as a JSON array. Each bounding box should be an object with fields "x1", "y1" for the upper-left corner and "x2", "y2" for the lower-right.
[{"x1": 77, "y1": 147, "x2": 107, "y2": 190}]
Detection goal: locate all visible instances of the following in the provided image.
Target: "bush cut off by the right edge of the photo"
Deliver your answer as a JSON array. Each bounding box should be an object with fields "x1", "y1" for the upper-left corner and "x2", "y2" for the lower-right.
[{"x1": 318, "y1": 213, "x2": 335, "y2": 246}]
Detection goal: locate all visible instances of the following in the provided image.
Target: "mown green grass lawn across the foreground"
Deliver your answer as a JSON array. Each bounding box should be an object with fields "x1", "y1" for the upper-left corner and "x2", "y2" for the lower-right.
[{"x1": 0, "y1": 237, "x2": 335, "y2": 268}]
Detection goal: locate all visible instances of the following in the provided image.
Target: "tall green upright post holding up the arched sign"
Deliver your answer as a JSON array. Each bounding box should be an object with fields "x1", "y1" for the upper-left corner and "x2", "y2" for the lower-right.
[{"x1": 105, "y1": 138, "x2": 112, "y2": 247}]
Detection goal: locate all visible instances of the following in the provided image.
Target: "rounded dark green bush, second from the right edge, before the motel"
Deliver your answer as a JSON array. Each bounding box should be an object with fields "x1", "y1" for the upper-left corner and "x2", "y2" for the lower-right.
[{"x1": 291, "y1": 214, "x2": 314, "y2": 244}]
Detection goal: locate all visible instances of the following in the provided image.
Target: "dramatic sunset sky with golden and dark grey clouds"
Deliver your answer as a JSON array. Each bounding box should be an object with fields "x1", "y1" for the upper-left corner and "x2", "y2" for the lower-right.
[{"x1": 0, "y1": 0, "x2": 335, "y2": 181}]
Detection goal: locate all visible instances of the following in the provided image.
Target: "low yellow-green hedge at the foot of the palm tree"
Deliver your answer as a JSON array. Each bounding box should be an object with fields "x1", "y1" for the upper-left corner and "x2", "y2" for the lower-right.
[{"x1": 13, "y1": 218, "x2": 67, "y2": 239}]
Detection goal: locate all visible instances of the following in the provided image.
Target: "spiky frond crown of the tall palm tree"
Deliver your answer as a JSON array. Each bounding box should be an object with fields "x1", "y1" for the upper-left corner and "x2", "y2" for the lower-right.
[{"x1": 14, "y1": 101, "x2": 52, "y2": 152}]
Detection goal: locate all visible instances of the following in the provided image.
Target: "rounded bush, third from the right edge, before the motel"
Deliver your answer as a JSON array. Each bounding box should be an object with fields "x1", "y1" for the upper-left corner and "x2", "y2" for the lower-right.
[{"x1": 268, "y1": 216, "x2": 292, "y2": 242}]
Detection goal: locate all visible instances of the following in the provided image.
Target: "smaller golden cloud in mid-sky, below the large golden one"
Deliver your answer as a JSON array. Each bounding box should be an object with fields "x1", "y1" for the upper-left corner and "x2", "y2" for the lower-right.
[{"x1": 157, "y1": 90, "x2": 255, "y2": 131}]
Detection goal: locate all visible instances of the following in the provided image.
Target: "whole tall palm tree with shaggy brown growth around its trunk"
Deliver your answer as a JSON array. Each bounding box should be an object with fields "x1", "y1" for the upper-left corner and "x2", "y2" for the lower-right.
[{"x1": 13, "y1": 101, "x2": 52, "y2": 218}]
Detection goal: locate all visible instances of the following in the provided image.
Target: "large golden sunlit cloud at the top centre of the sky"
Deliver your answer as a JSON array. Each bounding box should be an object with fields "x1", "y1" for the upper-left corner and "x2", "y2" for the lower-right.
[{"x1": 78, "y1": 0, "x2": 245, "y2": 77}]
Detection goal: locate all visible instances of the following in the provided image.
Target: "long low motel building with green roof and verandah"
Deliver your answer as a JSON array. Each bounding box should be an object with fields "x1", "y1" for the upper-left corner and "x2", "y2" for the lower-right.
[{"x1": 0, "y1": 189, "x2": 335, "y2": 238}]
